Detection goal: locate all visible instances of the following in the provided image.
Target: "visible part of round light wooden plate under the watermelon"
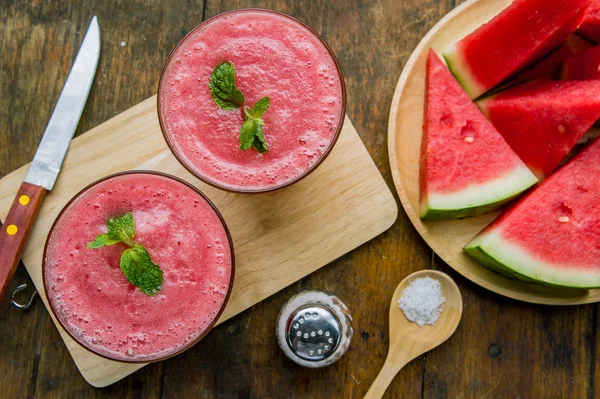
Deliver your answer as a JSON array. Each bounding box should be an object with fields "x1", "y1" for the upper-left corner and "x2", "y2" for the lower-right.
[{"x1": 388, "y1": 0, "x2": 600, "y2": 305}]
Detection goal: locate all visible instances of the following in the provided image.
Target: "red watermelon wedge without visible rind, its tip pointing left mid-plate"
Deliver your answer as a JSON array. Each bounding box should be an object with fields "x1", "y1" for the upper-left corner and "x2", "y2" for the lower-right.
[{"x1": 478, "y1": 80, "x2": 600, "y2": 180}]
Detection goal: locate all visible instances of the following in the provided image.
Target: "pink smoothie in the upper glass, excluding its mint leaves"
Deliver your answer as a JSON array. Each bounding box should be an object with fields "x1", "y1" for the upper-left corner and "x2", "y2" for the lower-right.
[{"x1": 158, "y1": 10, "x2": 344, "y2": 191}]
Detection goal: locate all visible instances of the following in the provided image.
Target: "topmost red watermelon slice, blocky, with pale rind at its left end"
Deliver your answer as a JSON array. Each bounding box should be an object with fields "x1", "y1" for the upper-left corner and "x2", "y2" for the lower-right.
[{"x1": 444, "y1": 0, "x2": 590, "y2": 98}]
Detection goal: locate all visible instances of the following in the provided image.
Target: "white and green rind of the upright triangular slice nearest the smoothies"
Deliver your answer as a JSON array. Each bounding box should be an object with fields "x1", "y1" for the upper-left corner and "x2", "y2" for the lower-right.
[{"x1": 420, "y1": 165, "x2": 538, "y2": 220}]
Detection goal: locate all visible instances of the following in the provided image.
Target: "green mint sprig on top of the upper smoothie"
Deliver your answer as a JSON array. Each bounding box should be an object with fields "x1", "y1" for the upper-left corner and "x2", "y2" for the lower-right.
[{"x1": 208, "y1": 61, "x2": 270, "y2": 153}]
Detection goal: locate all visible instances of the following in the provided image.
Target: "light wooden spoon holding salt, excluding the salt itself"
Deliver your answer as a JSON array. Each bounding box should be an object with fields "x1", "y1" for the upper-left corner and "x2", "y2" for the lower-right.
[{"x1": 365, "y1": 270, "x2": 462, "y2": 399}]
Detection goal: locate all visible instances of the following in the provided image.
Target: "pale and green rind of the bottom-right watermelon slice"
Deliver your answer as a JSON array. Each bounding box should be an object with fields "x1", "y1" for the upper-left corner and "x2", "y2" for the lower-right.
[{"x1": 463, "y1": 230, "x2": 600, "y2": 289}]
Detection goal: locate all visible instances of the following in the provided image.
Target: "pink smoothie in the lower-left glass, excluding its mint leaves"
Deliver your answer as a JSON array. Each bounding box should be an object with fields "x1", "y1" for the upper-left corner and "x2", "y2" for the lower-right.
[{"x1": 44, "y1": 173, "x2": 233, "y2": 361}]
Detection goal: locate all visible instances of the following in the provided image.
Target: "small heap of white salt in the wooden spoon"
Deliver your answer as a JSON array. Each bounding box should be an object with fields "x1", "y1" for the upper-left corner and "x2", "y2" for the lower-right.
[{"x1": 398, "y1": 277, "x2": 446, "y2": 327}]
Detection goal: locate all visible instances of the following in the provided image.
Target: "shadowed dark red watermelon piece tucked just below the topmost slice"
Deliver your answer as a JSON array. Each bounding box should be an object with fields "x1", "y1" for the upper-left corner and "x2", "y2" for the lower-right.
[{"x1": 507, "y1": 34, "x2": 593, "y2": 86}]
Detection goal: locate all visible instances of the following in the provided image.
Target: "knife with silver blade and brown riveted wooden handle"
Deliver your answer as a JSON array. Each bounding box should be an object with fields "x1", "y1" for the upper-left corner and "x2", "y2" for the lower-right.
[{"x1": 0, "y1": 16, "x2": 100, "y2": 301}]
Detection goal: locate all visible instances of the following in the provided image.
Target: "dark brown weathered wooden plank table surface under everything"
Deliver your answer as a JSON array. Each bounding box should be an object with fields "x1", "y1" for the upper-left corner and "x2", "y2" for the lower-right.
[{"x1": 0, "y1": 0, "x2": 600, "y2": 398}]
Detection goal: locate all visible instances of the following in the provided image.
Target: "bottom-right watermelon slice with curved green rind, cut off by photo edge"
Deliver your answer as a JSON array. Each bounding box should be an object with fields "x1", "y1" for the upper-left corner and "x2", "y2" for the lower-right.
[{"x1": 464, "y1": 140, "x2": 600, "y2": 288}]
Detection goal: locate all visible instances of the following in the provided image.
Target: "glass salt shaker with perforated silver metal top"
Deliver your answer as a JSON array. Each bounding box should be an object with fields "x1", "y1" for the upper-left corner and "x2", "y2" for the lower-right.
[{"x1": 276, "y1": 291, "x2": 354, "y2": 368}]
